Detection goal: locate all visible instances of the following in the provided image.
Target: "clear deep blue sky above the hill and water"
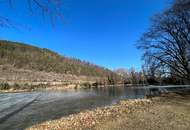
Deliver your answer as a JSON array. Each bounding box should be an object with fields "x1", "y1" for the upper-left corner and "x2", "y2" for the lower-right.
[{"x1": 0, "y1": 0, "x2": 168, "y2": 69}]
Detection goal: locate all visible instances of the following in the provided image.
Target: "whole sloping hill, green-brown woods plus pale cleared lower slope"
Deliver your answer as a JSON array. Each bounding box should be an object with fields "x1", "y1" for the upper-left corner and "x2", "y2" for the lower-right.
[{"x1": 0, "y1": 40, "x2": 120, "y2": 87}]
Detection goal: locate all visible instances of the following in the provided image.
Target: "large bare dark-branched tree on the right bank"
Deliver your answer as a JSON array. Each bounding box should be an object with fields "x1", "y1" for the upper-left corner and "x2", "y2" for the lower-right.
[{"x1": 137, "y1": 0, "x2": 190, "y2": 82}]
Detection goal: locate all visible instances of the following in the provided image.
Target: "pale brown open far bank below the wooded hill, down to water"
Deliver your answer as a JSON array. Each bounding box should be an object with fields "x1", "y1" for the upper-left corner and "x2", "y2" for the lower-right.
[{"x1": 0, "y1": 65, "x2": 122, "y2": 93}]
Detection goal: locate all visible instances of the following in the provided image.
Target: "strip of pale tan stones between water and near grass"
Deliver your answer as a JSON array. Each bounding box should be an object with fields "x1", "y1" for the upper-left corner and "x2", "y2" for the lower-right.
[{"x1": 28, "y1": 99, "x2": 152, "y2": 130}]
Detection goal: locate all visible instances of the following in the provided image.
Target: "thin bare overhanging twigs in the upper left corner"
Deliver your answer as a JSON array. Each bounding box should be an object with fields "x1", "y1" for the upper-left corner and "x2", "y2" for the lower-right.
[{"x1": 0, "y1": 0, "x2": 63, "y2": 27}]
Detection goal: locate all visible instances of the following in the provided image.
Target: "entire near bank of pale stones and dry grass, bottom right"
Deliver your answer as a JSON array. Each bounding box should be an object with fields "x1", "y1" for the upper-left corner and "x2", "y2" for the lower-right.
[{"x1": 28, "y1": 93, "x2": 190, "y2": 130}]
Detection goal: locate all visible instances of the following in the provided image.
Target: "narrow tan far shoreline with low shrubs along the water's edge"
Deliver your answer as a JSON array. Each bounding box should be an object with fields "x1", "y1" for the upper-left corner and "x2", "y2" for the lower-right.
[{"x1": 0, "y1": 82, "x2": 190, "y2": 93}]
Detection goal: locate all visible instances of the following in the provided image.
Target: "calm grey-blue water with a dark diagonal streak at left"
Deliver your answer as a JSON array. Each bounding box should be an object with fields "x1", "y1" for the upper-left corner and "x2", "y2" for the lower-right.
[{"x1": 0, "y1": 86, "x2": 189, "y2": 130}]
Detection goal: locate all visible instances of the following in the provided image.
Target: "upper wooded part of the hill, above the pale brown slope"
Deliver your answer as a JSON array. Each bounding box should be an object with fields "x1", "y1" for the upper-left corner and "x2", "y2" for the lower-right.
[{"x1": 0, "y1": 40, "x2": 117, "y2": 77}]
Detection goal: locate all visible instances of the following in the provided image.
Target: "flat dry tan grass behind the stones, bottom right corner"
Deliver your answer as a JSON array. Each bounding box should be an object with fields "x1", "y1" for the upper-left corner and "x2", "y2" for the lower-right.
[{"x1": 94, "y1": 95, "x2": 190, "y2": 130}]
